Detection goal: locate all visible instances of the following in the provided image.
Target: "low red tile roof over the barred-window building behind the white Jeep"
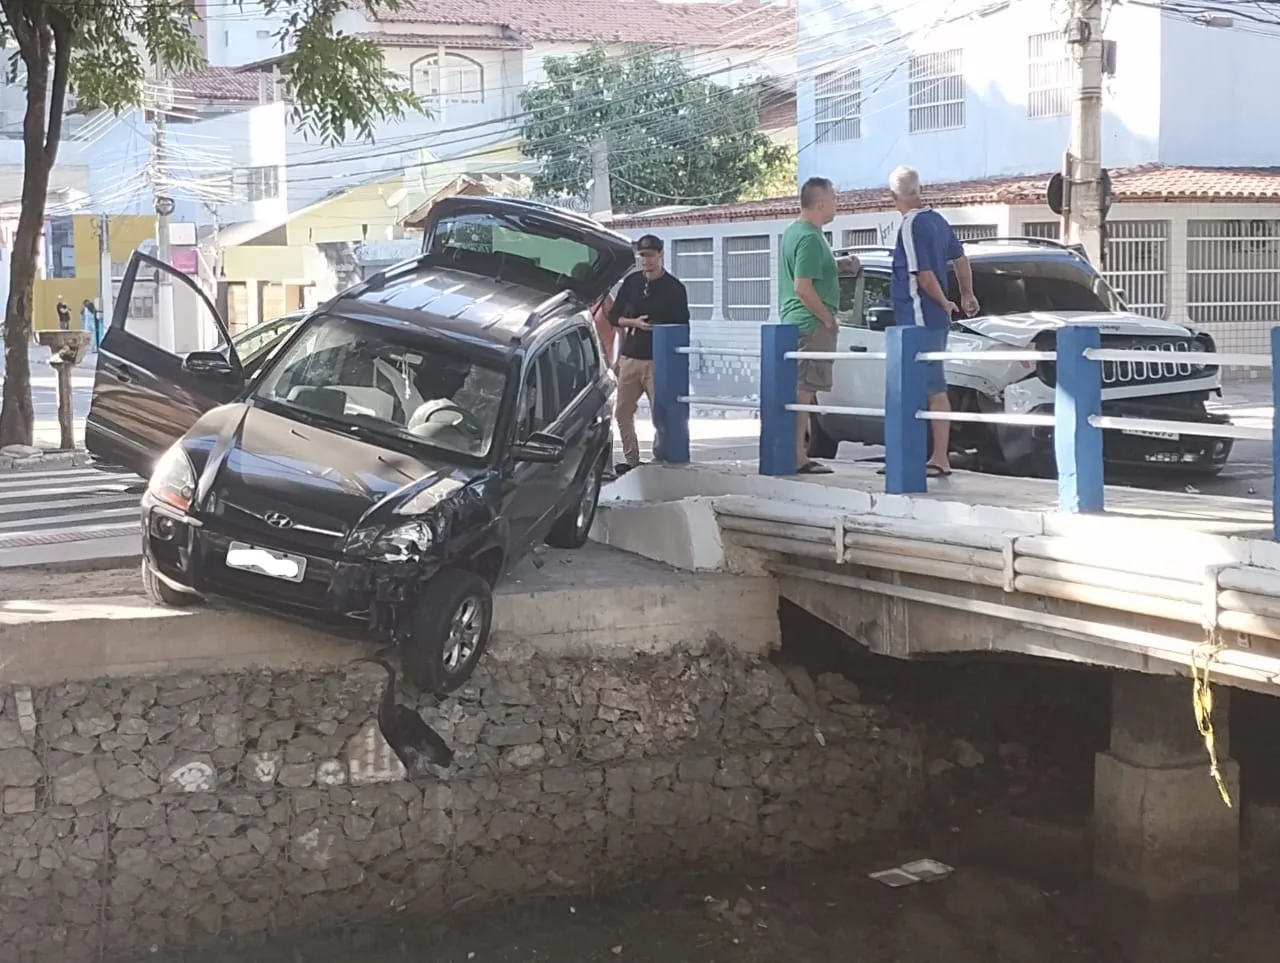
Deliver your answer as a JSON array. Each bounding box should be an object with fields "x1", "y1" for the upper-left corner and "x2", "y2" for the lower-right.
[{"x1": 612, "y1": 164, "x2": 1280, "y2": 228}]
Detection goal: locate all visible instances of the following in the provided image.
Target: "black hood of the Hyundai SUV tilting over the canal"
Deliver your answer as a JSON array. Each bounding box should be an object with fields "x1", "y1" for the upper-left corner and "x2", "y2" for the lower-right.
[{"x1": 194, "y1": 405, "x2": 457, "y2": 535}]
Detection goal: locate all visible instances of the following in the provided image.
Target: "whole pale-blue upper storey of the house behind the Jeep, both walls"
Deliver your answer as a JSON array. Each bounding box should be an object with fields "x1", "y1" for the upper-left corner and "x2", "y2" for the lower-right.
[{"x1": 796, "y1": 0, "x2": 1280, "y2": 190}]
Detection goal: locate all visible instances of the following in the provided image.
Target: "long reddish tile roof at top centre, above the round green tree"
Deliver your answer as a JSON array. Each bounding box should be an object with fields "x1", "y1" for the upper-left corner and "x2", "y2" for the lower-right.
[{"x1": 375, "y1": 0, "x2": 796, "y2": 50}]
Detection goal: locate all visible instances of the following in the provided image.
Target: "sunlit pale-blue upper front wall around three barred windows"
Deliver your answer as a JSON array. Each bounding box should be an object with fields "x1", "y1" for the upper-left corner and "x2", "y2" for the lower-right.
[{"x1": 797, "y1": 0, "x2": 1161, "y2": 188}]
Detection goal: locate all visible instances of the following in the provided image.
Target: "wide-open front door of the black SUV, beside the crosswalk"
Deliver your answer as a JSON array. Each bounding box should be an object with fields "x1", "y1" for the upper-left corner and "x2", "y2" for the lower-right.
[{"x1": 84, "y1": 251, "x2": 244, "y2": 478}]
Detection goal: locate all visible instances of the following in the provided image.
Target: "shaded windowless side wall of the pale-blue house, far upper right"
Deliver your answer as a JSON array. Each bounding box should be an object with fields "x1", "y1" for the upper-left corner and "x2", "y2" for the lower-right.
[{"x1": 1160, "y1": 15, "x2": 1280, "y2": 166}]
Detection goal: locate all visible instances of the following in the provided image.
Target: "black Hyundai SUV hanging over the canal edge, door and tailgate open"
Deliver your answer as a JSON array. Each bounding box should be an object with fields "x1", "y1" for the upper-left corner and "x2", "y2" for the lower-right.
[{"x1": 86, "y1": 197, "x2": 634, "y2": 693}]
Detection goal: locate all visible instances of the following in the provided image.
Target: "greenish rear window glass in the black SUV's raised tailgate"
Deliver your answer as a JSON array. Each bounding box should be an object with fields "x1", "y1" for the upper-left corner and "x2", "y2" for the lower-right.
[{"x1": 428, "y1": 211, "x2": 605, "y2": 291}]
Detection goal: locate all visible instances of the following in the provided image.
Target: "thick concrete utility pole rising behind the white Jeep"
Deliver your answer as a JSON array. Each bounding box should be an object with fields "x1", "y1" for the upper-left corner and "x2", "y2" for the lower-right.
[{"x1": 1062, "y1": 0, "x2": 1105, "y2": 269}]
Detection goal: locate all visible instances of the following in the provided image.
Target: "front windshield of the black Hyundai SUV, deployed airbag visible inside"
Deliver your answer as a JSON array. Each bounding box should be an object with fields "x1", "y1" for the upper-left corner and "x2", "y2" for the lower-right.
[{"x1": 252, "y1": 309, "x2": 507, "y2": 458}]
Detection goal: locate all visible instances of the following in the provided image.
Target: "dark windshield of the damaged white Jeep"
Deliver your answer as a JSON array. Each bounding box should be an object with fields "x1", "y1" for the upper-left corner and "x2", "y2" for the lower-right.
[{"x1": 950, "y1": 257, "x2": 1123, "y2": 315}]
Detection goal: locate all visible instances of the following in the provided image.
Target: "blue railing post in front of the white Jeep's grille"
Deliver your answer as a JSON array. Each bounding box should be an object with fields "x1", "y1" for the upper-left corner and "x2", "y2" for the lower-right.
[{"x1": 1053, "y1": 324, "x2": 1106, "y2": 514}]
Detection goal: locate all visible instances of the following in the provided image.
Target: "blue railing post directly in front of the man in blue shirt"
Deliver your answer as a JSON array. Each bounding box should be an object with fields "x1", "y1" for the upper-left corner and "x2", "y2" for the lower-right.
[{"x1": 884, "y1": 324, "x2": 929, "y2": 494}]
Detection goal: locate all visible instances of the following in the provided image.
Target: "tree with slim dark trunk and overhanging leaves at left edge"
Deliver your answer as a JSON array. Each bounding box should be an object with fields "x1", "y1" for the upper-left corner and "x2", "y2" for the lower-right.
[{"x1": 0, "y1": 0, "x2": 417, "y2": 446}]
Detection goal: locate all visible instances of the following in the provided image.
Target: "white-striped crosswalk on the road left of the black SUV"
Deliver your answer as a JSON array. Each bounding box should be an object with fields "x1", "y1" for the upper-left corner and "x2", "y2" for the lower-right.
[{"x1": 0, "y1": 469, "x2": 143, "y2": 544}]
